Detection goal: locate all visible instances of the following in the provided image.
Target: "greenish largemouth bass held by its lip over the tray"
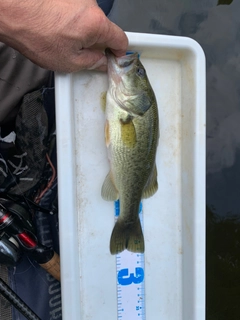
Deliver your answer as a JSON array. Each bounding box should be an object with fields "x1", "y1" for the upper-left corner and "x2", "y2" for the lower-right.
[{"x1": 102, "y1": 51, "x2": 159, "y2": 254}]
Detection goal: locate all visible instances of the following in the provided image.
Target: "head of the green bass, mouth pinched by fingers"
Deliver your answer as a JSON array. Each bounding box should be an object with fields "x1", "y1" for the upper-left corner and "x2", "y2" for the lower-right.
[{"x1": 106, "y1": 50, "x2": 155, "y2": 115}]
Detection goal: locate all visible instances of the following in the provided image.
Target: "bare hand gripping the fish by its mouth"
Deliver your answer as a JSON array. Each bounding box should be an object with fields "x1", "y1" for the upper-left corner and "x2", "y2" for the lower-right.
[{"x1": 0, "y1": 0, "x2": 128, "y2": 72}]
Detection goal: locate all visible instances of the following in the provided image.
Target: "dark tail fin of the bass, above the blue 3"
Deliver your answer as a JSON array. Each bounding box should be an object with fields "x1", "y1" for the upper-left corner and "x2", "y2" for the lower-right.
[{"x1": 110, "y1": 219, "x2": 144, "y2": 254}]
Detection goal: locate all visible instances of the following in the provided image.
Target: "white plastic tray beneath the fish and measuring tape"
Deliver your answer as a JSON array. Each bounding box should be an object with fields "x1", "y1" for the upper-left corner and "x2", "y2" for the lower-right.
[{"x1": 56, "y1": 33, "x2": 205, "y2": 320}]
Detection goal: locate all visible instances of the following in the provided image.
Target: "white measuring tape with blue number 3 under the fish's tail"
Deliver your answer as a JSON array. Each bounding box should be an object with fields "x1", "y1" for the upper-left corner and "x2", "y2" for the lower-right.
[{"x1": 115, "y1": 201, "x2": 145, "y2": 320}]
